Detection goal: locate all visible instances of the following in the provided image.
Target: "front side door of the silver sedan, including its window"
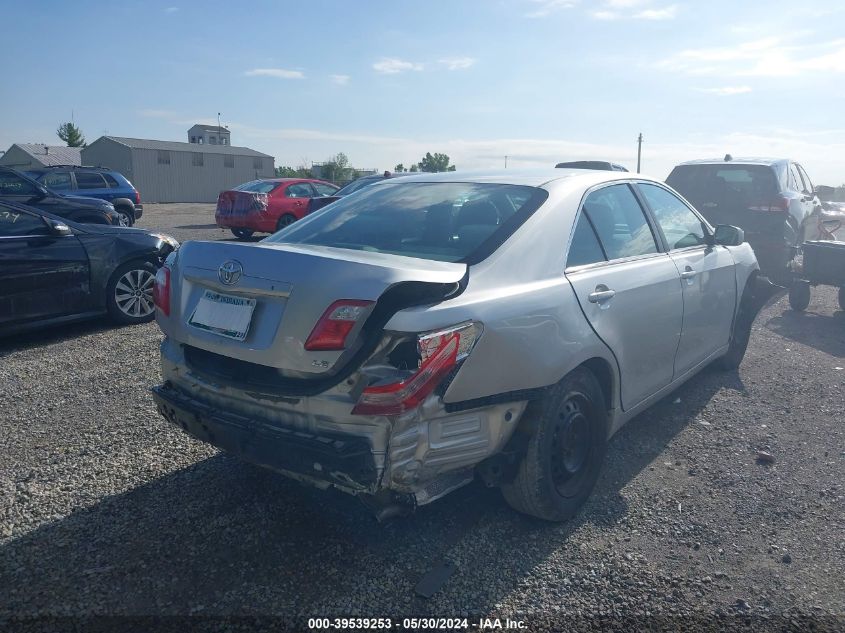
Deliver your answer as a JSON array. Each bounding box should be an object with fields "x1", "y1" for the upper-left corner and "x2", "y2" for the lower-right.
[{"x1": 636, "y1": 183, "x2": 737, "y2": 377}]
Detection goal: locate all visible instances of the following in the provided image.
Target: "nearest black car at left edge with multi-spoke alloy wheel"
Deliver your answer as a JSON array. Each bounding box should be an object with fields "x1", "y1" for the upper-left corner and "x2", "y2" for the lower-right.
[{"x1": 0, "y1": 201, "x2": 179, "y2": 336}]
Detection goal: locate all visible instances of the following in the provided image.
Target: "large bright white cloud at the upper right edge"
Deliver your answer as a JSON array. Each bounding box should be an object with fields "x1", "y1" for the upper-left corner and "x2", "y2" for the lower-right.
[{"x1": 657, "y1": 36, "x2": 845, "y2": 77}]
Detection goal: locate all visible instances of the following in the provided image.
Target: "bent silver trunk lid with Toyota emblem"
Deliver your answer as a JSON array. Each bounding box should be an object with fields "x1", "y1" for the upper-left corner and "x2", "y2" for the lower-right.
[{"x1": 162, "y1": 241, "x2": 467, "y2": 378}]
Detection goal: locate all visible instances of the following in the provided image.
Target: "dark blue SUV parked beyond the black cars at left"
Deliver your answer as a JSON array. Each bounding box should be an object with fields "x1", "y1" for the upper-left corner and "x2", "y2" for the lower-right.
[{"x1": 27, "y1": 165, "x2": 144, "y2": 226}]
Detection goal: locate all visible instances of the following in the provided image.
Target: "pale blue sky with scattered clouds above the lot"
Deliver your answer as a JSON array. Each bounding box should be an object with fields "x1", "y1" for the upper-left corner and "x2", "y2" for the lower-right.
[{"x1": 0, "y1": 0, "x2": 845, "y2": 185}]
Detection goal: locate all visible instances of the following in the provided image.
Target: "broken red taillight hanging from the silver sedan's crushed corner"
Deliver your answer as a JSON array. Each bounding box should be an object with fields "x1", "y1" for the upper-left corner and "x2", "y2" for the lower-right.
[{"x1": 352, "y1": 323, "x2": 481, "y2": 415}]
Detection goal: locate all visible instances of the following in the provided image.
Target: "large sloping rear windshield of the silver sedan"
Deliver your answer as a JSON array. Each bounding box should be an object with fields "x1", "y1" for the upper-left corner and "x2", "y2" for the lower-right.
[{"x1": 266, "y1": 182, "x2": 548, "y2": 264}]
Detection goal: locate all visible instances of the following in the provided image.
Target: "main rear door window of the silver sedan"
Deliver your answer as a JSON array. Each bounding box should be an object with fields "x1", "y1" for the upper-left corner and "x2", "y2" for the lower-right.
[{"x1": 583, "y1": 184, "x2": 658, "y2": 260}]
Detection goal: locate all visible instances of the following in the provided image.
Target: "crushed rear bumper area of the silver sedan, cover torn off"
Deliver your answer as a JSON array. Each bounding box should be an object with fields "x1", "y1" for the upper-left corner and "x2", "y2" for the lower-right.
[{"x1": 148, "y1": 337, "x2": 526, "y2": 505}]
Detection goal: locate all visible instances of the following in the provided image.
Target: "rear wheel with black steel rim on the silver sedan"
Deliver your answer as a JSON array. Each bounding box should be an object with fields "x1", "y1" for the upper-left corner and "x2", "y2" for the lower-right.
[{"x1": 502, "y1": 367, "x2": 607, "y2": 521}]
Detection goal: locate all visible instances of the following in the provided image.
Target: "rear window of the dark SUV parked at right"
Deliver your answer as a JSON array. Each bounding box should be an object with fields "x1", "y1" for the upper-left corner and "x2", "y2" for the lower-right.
[{"x1": 666, "y1": 165, "x2": 779, "y2": 206}]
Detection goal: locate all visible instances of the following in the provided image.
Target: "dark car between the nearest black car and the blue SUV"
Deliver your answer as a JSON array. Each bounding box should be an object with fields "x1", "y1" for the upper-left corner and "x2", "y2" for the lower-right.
[{"x1": 0, "y1": 167, "x2": 120, "y2": 225}]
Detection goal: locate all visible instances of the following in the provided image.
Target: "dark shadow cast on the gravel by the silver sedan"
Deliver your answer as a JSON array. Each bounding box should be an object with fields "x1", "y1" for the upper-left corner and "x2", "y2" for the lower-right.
[{"x1": 0, "y1": 372, "x2": 744, "y2": 619}]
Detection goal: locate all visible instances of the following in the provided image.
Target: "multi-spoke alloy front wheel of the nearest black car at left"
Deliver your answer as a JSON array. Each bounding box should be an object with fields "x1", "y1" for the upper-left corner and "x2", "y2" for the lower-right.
[{"x1": 106, "y1": 261, "x2": 156, "y2": 325}]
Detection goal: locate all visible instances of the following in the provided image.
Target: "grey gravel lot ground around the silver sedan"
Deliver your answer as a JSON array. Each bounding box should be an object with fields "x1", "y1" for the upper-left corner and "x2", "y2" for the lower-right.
[{"x1": 0, "y1": 204, "x2": 845, "y2": 631}]
